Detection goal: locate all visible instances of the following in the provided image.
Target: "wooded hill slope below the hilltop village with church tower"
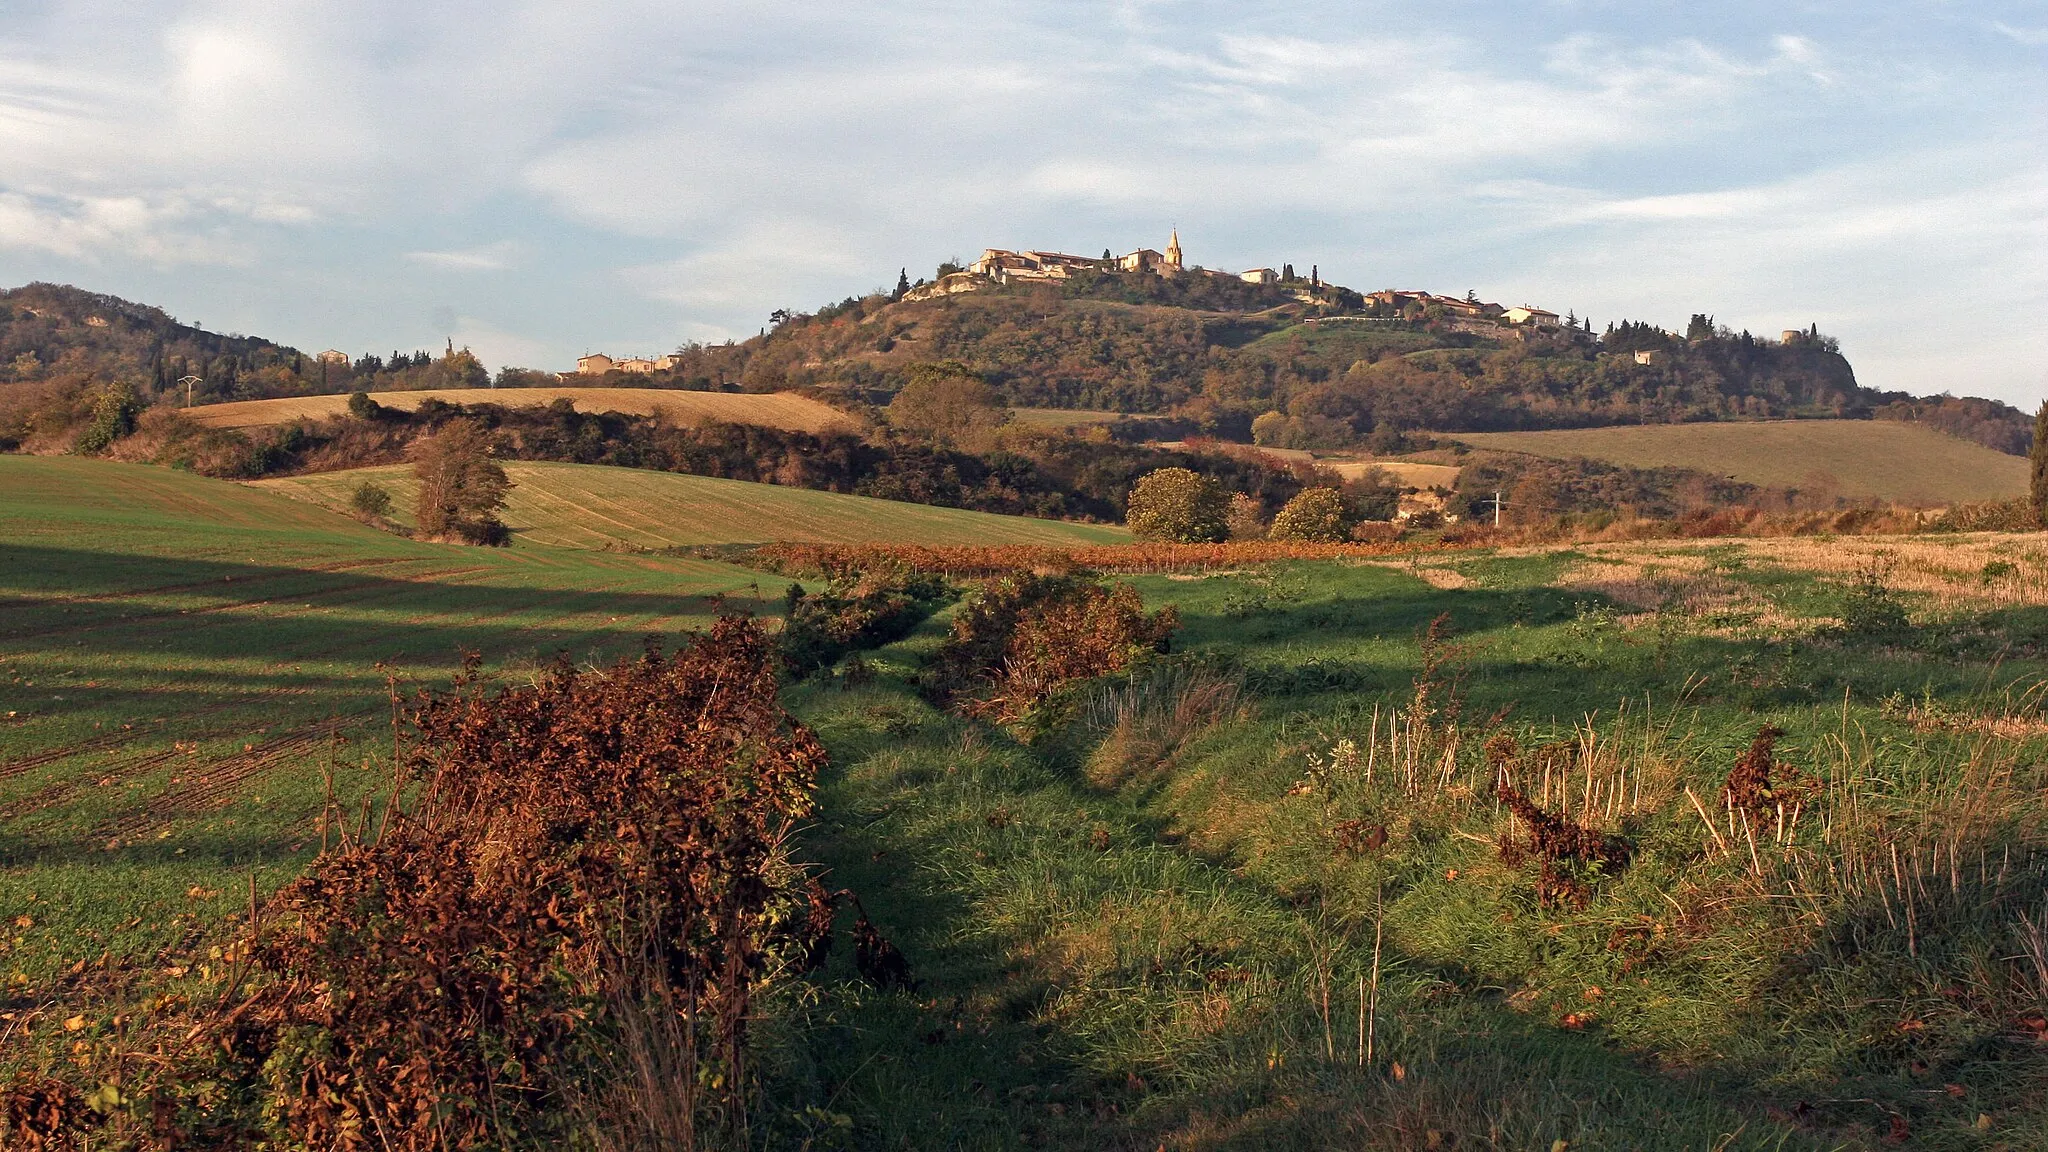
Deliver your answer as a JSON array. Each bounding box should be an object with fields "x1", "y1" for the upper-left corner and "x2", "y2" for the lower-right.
[{"x1": 655, "y1": 273, "x2": 2032, "y2": 453}]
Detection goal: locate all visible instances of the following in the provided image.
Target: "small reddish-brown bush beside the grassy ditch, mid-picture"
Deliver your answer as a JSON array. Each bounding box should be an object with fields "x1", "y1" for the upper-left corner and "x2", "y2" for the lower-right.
[{"x1": 924, "y1": 574, "x2": 1180, "y2": 722}]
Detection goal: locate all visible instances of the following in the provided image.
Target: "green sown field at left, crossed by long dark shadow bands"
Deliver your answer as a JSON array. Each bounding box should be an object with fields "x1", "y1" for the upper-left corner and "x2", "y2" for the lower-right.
[{"x1": 0, "y1": 455, "x2": 782, "y2": 986}]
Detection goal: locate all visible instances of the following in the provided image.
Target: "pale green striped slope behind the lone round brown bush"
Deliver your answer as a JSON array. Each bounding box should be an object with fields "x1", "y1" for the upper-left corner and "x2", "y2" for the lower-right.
[{"x1": 254, "y1": 461, "x2": 1128, "y2": 547}]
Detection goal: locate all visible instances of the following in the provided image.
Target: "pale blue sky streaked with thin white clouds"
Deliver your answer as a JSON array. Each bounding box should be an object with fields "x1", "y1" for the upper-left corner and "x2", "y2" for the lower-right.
[{"x1": 0, "y1": 0, "x2": 2048, "y2": 408}]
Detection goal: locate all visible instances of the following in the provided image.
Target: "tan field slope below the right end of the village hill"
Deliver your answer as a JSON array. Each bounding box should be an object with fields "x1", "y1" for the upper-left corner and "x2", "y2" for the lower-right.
[{"x1": 1452, "y1": 420, "x2": 2028, "y2": 504}]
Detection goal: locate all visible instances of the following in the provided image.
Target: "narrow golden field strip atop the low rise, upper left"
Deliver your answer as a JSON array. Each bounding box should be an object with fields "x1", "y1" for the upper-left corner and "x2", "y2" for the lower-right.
[{"x1": 186, "y1": 387, "x2": 858, "y2": 433}]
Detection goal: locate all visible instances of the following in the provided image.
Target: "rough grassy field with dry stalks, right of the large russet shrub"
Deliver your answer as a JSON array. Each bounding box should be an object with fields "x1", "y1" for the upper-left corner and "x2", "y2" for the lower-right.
[{"x1": 766, "y1": 537, "x2": 2048, "y2": 1150}]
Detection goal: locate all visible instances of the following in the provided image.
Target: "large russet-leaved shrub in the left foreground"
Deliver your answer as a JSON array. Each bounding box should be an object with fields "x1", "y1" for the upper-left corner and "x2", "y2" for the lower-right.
[{"x1": 0, "y1": 617, "x2": 831, "y2": 1152}]
